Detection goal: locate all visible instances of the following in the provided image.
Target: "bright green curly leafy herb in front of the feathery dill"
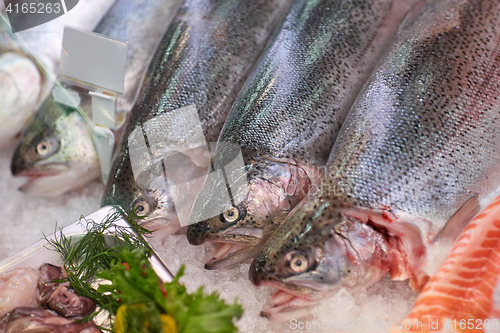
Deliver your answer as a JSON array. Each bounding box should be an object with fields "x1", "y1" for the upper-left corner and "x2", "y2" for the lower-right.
[{"x1": 98, "y1": 249, "x2": 243, "y2": 333}]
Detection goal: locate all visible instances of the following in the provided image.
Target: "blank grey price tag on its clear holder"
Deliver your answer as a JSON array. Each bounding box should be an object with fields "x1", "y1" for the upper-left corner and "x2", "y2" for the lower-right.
[{"x1": 58, "y1": 27, "x2": 128, "y2": 183}]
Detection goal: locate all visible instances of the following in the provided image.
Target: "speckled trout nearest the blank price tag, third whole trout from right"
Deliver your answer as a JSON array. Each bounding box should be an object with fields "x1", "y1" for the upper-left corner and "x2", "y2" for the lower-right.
[{"x1": 103, "y1": 0, "x2": 290, "y2": 237}]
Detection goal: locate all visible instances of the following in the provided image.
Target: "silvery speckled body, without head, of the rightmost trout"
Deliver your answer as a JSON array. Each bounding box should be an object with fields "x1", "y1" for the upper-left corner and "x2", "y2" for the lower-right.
[{"x1": 319, "y1": 0, "x2": 500, "y2": 230}]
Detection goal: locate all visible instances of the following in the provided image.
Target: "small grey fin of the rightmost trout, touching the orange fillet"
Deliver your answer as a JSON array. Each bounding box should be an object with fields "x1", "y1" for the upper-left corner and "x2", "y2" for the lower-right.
[{"x1": 434, "y1": 193, "x2": 480, "y2": 243}]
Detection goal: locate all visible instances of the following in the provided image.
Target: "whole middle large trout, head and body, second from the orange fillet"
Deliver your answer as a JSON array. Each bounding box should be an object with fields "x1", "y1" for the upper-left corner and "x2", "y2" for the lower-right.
[{"x1": 187, "y1": 0, "x2": 416, "y2": 268}]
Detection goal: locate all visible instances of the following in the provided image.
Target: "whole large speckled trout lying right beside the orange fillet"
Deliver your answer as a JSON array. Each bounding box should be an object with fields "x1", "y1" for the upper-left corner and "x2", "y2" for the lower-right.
[{"x1": 250, "y1": 0, "x2": 500, "y2": 317}]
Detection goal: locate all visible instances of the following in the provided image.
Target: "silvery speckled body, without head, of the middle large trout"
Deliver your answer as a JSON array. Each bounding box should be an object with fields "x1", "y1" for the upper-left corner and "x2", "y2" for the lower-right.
[{"x1": 219, "y1": 0, "x2": 400, "y2": 165}]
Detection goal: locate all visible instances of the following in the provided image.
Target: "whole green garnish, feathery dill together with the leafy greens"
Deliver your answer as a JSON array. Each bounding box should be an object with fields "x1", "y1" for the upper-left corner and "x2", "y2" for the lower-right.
[{"x1": 49, "y1": 211, "x2": 243, "y2": 333}]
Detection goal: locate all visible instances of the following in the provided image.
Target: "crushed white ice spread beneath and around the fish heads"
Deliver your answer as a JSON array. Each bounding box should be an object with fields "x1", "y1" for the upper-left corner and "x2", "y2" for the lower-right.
[{"x1": 0, "y1": 148, "x2": 416, "y2": 333}]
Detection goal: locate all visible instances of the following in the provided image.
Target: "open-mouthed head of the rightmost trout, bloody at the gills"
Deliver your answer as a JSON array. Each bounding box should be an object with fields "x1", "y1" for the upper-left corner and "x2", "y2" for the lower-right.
[{"x1": 249, "y1": 201, "x2": 394, "y2": 320}]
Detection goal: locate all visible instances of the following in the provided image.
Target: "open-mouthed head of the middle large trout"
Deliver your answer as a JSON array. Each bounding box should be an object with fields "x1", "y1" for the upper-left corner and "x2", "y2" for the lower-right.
[{"x1": 187, "y1": 159, "x2": 309, "y2": 269}]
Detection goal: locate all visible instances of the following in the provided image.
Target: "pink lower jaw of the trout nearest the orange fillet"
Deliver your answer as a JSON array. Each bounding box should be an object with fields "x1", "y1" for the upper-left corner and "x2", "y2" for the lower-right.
[{"x1": 260, "y1": 282, "x2": 326, "y2": 321}]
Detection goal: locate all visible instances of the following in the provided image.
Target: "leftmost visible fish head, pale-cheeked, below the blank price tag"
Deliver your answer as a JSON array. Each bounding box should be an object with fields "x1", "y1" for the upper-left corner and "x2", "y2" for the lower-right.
[{"x1": 11, "y1": 96, "x2": 100, "y2": 196}]
